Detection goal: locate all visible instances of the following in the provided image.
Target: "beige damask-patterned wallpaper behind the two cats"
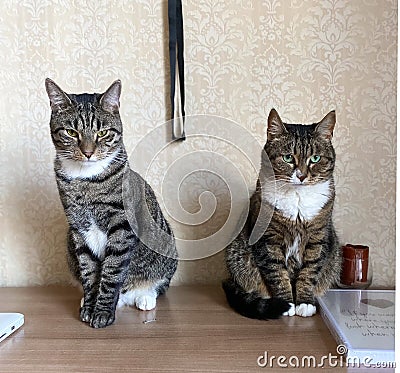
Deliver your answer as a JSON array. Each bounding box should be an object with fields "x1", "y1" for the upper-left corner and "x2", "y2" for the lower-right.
[{"x1": 0, "y1": 0, "x2": 397, "y2": 286}]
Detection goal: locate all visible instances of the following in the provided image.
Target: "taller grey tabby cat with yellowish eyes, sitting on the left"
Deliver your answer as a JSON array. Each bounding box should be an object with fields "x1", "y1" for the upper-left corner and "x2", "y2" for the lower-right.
[{"x1": 46, "y1": 79, "x2": 177, "y2": 328}]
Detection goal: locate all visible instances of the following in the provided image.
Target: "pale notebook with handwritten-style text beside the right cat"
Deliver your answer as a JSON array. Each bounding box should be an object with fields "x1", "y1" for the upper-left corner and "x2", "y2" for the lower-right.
[{"x1": 318, "y1": 289, "x2": 395, "y2": 366}]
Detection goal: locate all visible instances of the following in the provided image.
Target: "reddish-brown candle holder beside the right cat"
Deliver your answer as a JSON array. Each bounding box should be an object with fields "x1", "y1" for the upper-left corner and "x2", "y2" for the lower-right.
[{"x1": 338, "y1": 244, "x2": 372, "y2": 289}]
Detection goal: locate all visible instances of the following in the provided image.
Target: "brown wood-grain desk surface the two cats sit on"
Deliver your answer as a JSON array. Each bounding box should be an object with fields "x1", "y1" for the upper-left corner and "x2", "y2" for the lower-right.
[{"x1": 0, "y1": 286, "x2": 364, "y2": 373}]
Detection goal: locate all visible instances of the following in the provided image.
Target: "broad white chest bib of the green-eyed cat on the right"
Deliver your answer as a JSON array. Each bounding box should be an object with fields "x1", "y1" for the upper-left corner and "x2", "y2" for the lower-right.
[{"x1": 263, "y1": 180, "x2": 331, "y2": 220}]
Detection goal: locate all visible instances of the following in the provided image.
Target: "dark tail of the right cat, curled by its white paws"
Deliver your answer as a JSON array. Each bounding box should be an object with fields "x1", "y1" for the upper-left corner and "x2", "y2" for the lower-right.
[{"x1": 222, "y1": 279, "x2": 290, "y2": 320}]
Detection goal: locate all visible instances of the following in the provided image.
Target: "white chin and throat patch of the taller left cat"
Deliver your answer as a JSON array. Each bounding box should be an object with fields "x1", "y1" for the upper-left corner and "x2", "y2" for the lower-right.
[{"x1": 61, "y1": 150, "x2": 118, "y2": 179}]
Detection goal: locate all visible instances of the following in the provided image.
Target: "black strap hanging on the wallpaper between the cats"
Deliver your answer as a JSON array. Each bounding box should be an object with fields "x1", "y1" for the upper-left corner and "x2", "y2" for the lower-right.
[{"x1": 168, "y1": 0, "x2": 186, "y2": 140}]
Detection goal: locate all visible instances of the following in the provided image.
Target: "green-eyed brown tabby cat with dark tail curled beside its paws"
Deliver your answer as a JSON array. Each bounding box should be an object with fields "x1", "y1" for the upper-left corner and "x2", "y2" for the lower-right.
[{"x1": 223, "y1": 109, "x2": 341, "y2": 319}]
